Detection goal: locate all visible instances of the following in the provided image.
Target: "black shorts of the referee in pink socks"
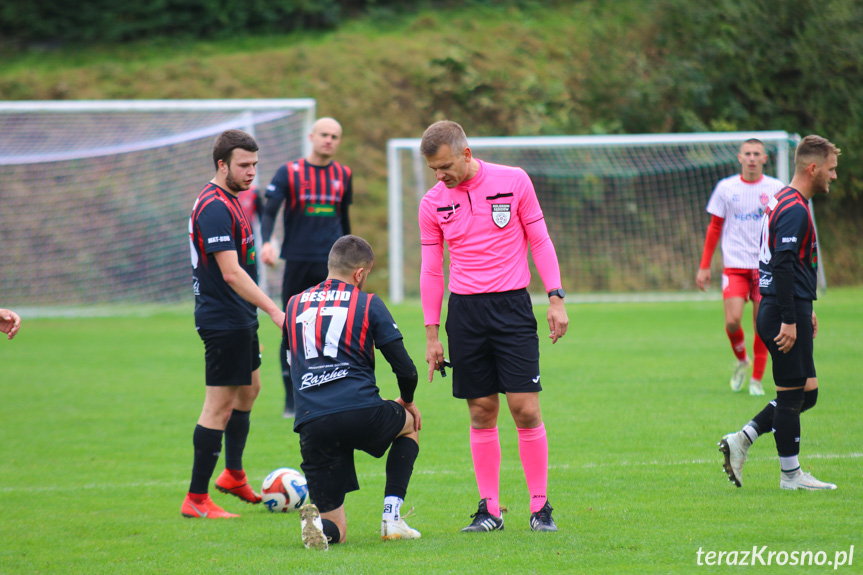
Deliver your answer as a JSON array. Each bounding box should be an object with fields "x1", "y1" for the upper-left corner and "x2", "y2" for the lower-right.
[{"x1": 446, "y1": 289, "x2": 542, "y2": 399}]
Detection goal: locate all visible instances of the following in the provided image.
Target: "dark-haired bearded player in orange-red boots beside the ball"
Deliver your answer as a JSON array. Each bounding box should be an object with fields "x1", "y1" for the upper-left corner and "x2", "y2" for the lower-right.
[{"x1": 181, "y1": 130, "x2": 285, "y2": 519}]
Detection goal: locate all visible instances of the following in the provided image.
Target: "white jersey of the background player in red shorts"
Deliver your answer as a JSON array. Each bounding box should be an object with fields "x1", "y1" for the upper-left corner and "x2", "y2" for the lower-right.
[{"x1": 707, "y1": 174, "x2": 784, "y2": 269}]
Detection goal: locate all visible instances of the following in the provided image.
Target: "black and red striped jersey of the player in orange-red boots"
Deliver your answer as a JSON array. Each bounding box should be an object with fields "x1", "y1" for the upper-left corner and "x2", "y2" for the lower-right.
[{"x1": 189, "y1": 183, "x2": 258, "y2": 330}]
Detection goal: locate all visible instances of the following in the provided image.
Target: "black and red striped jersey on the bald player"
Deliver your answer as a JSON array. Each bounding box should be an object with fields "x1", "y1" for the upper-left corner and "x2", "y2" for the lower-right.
[{"x1": 262, "y1": 158, "x2": 353, "y2": 262}]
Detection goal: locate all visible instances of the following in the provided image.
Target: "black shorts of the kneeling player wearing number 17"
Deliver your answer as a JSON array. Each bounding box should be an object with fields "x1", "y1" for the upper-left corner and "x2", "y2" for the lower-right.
[{"x1": 297, "y1": 401, "x2": 407, "y2": 513}]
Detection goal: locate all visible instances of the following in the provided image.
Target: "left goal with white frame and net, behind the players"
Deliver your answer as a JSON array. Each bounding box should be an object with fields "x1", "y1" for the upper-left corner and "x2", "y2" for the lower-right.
[{"x1": 0, "y1": 99, "x2": 315, "y2": 307}]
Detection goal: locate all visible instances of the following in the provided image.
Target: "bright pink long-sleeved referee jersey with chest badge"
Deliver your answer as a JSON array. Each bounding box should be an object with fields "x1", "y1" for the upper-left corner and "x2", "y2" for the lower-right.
[{"x1": 419, "y1": 160, "x2": 561, "y2": 325}]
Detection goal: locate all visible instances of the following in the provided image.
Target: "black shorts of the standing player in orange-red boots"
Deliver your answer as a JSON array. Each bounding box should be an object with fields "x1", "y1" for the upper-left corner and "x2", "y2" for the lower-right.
[{"x1": 198, "y1": 327, "x2": 261, "y2": 386}]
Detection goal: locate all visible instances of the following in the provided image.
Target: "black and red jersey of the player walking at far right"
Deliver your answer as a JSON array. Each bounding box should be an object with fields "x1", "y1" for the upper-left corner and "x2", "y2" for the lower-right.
[{"x1": 759, "y1": 186, "x2": 818, "y2": 300}]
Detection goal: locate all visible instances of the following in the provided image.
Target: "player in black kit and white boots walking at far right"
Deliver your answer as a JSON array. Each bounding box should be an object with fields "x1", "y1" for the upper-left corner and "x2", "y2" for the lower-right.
[{"x1": 719, "y1": 135, "x2": 841, "y2": 490}]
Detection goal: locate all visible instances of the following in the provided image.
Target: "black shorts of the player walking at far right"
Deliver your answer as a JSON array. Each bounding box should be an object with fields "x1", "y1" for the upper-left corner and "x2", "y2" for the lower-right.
[{"x1": 756, "y1": 296, "x2": 815, "y2": 387}]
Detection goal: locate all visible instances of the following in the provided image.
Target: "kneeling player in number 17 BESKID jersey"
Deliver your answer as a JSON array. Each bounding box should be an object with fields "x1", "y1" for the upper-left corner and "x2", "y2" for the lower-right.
[{"x1": 284, "y1": 236, "x2": 421, "y2": 549}]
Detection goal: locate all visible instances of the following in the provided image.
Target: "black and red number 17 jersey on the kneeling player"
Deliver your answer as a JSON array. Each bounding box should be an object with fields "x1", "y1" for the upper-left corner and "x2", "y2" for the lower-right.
[{"x1": 284, "y1": 279, "x2": 402, "y2": 429}]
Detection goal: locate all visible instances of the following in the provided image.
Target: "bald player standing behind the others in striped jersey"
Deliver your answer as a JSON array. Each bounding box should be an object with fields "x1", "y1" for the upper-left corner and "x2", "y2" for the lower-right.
[{"x1": 261, "y1": 118, "x2": 353, "y2": 417}]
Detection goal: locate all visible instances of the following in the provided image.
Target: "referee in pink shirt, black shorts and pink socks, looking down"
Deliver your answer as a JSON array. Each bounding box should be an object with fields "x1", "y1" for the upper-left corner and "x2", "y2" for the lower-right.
[{"x1": 419, "y1": 121, "x2": 569, "y2": 532}]
